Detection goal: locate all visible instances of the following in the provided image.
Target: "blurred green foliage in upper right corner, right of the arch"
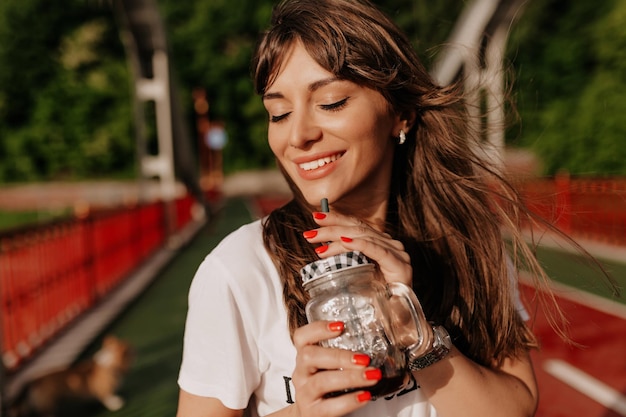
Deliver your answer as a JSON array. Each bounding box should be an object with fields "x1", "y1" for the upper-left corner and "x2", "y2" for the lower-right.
[{"x1": 509, "y1": 0, "x2": 626, "y2": 176}]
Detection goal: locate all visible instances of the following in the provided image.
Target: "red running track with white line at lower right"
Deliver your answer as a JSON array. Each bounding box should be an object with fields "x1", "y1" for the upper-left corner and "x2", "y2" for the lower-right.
[{"x1": 256, "y1": 198, "x2": 626, "y2": 417}]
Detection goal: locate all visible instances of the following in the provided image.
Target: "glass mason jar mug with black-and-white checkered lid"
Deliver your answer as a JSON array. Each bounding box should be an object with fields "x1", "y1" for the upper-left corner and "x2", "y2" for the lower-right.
[{"x1": 300, "y1": 251, "x2": 430, "y2": 398}]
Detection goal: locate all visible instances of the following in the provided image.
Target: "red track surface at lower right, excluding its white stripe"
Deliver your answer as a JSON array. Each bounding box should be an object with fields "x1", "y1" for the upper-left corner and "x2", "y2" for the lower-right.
[{"x1": 256, "y1": 197, "x2": 626, "y2": 417}]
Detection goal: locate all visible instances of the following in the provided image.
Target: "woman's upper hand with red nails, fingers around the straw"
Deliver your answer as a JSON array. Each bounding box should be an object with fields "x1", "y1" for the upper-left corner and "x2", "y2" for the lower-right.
[{"x1": 303, "y1": 212, "x2": 413, "y2": 286}]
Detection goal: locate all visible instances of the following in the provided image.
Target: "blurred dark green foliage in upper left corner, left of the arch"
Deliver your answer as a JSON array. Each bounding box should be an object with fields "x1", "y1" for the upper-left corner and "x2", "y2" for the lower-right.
[{"x1": 0, "y1": 0, "x2": 135, "y2": 182}]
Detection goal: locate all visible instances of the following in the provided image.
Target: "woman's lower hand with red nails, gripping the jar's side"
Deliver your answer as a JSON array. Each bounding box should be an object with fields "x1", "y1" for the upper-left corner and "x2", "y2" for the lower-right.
[{"x1": 292, "y1": 321, "x2": 382, "y2": 417}]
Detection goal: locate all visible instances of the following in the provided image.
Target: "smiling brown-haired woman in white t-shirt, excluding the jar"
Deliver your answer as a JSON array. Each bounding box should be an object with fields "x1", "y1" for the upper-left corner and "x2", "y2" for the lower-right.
[{"x1": 179, "y1": 0, "x2": 537, "y2": 417}]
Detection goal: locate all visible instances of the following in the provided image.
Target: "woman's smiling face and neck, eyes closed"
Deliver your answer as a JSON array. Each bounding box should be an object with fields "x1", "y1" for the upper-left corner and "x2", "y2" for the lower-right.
[{"x1": 263, "y1": 43, "x2": 402, "y2": 213}]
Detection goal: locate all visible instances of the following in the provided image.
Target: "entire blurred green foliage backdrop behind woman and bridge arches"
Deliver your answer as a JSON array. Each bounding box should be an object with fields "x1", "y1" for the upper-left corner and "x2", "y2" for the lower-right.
[{"x1": 0, "y1": 0, "x2": 626, "y2": 183}]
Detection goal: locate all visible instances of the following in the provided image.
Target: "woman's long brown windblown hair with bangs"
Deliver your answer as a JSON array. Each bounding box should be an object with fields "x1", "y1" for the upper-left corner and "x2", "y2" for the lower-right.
[{"x1": 252, "y1": 0, "x2": 541, "y2": 366}]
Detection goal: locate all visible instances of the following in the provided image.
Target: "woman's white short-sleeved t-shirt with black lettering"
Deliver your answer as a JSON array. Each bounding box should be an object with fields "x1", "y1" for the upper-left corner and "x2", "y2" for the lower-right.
[{"x1": 178, "y1": 220, "x2": 520, "y2": 417}]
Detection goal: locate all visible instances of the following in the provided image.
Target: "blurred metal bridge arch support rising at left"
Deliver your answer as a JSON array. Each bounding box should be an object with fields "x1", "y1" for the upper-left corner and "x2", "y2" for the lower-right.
[{"x1": 113, "y1": 0, "x2": 209, "y2": 234}]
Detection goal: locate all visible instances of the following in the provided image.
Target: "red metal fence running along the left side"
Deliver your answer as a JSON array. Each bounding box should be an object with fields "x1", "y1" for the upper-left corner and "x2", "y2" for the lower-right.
[{"x1": 0, "y1": 195, "x2": 195, "y2": 372}]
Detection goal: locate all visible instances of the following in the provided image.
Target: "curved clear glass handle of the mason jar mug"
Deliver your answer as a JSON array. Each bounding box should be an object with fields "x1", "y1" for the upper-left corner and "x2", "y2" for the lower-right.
[{"x1": 387, "y1": 282, "x2": 433, "y2": 354}]
